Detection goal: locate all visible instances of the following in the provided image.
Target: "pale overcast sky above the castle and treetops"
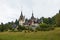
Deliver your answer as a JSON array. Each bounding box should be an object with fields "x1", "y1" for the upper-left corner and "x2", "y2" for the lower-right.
[{"x1": 0, "y1": 0, "x2": 60, "y2": 23}]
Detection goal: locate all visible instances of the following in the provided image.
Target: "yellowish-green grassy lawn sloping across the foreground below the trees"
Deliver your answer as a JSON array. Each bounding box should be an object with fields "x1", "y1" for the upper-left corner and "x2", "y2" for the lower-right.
[{"x1": 0, "y1": 28, "x2": 60, "y2": 40}]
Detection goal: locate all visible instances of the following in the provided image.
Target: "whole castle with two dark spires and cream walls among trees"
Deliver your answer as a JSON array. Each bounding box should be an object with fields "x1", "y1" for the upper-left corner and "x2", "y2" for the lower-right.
[{"x1": 19, "y1": 11, "x2": 40, "y2": 26}]
